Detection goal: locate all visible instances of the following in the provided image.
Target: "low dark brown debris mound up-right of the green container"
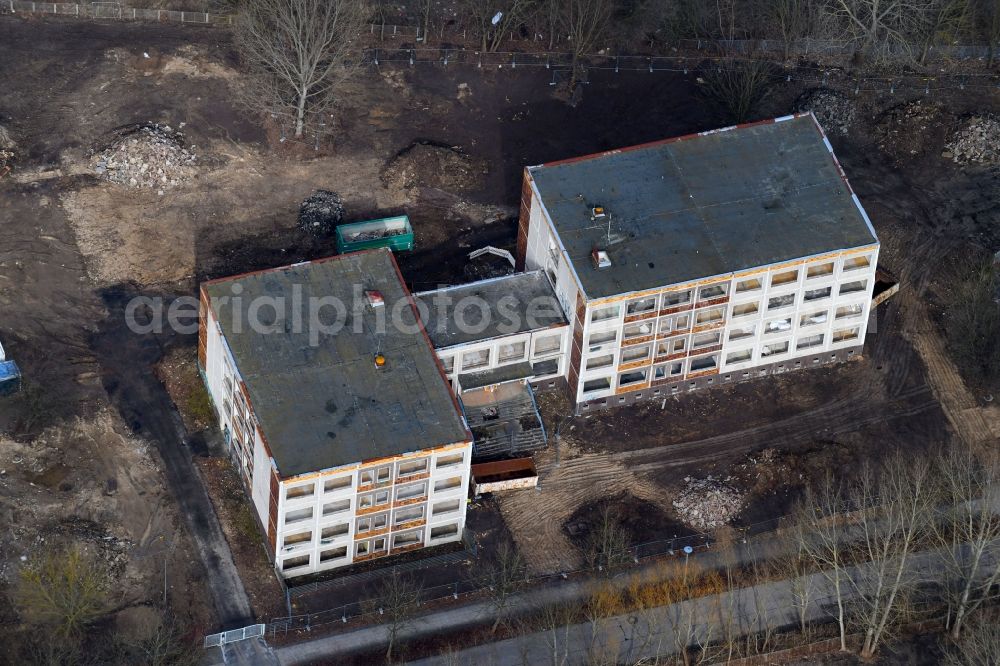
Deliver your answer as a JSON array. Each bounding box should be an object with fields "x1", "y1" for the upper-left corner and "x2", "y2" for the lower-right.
[{"x1": 382, "y1": 142, "x2": 487, "y2": 192}]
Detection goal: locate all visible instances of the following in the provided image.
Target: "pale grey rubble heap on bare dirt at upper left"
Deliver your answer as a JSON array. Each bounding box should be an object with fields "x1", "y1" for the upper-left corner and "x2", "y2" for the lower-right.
[{"x1": 94, "y1": 123, "x2": 196, "y2": 189}]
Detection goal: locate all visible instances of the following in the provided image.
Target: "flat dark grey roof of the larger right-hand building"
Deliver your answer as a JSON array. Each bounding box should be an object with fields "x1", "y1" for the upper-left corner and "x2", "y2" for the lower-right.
[{"x1": 528, "y1": 114, "x2": 878, "y2": 299}]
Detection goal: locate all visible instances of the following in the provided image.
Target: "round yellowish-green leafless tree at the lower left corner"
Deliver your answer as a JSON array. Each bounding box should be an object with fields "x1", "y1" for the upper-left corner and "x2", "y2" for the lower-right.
[{"x1": 17, "y1": 547, "x2": 109, "y2": 643}]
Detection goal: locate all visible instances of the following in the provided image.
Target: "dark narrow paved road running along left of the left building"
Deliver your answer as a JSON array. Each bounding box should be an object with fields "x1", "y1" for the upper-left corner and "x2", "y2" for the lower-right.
[{"x1": 91, "y1": 290, "x2": 253, "y2": 630}]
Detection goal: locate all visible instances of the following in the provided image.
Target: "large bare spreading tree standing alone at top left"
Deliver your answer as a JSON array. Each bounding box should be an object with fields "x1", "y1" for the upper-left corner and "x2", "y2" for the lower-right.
[{"x1": 233, "y1": 0, "x2": 368, "y2": 137}]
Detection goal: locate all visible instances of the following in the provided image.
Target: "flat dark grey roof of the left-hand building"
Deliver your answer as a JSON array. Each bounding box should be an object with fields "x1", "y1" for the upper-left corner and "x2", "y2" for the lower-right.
[{"x1": 205, "y1": 249, "x2": 469, "y2": 478}]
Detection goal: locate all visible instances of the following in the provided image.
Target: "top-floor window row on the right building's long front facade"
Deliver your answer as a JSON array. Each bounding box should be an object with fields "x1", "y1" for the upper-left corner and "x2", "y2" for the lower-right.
[{"x1": 590, "y1": 255, "x2": 871, "y2": 324}]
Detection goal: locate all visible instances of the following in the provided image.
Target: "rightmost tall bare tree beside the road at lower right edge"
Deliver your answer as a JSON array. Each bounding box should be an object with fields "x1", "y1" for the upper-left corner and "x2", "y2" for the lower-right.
[{"x1": 934, "y1": 450, "x2": 1000, "y2": 639}]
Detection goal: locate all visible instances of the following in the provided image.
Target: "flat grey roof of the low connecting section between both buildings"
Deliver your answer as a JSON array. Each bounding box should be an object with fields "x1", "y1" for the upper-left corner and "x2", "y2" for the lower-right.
[{"x1": 413, "y1": 271, "x2": 567, "y2": 349}]
